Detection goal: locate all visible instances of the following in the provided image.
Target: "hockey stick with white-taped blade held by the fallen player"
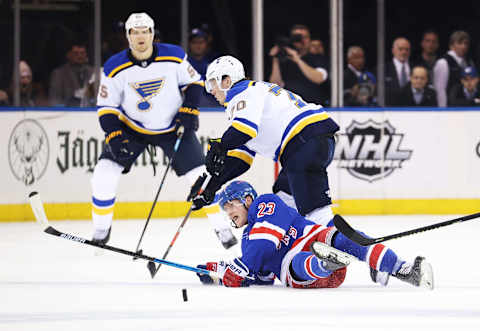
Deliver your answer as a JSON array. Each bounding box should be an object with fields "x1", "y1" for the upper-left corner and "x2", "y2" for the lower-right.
[{"x1": 28, "y1": 192, "x2": 218, "y2": 279}]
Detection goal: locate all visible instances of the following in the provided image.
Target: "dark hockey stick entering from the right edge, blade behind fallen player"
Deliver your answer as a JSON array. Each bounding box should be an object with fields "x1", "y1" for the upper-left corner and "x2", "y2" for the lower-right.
[{"x1": 333, "y1": 213, "x2": 480, "y2": 246}]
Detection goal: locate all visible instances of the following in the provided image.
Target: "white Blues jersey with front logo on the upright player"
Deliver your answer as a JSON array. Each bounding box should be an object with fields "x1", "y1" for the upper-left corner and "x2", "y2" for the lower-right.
[{"x1": 97, "y1": 44, "x2": 203, "y2": 135}]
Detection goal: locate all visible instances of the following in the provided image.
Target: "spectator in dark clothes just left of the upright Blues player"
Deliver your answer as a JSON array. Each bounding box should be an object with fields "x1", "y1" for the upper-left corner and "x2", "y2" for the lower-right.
[{"x1": 49, "y1": 43, "x2": 93, "y2": 107}]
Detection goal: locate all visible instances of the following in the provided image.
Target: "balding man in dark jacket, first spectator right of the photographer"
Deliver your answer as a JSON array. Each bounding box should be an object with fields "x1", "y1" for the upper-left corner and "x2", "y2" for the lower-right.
[{"x1": 343, "y1": 46, "x2": 377, "y2": 106}]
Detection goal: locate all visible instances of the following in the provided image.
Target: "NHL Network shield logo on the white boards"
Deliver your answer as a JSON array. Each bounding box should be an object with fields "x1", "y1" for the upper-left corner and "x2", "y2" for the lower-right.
[{"x1": 334, "y1": 119, "x2": 412, "y2": 182}]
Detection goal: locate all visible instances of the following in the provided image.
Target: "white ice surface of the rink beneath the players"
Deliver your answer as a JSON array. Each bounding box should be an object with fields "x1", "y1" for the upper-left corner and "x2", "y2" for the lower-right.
[{"x1": 0, "y1": 215, "x2": 480, "y2": 331}]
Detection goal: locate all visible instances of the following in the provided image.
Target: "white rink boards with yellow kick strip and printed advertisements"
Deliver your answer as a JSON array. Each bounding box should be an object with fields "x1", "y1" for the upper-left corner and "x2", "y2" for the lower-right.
[{"x1": 0, "y1": 108, "x2": 480, "y2": 221}]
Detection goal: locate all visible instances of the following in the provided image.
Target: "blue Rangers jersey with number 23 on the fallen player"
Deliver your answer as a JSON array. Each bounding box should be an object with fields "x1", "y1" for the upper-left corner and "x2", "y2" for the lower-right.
[{"x1": 240, "y1": 194, "x2": 319, "y2": 286}]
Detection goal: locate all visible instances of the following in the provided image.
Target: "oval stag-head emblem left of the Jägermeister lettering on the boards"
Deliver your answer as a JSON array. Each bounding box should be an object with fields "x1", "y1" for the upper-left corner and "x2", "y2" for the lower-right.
[{"x1": 8, "y1": 119, "x2": 50, "y2": 186}]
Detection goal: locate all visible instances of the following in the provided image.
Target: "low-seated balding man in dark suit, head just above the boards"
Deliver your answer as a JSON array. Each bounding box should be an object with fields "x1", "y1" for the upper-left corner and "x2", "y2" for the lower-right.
[{"x1": 394, "y1": 66, "x2": 437, "y2": 107}]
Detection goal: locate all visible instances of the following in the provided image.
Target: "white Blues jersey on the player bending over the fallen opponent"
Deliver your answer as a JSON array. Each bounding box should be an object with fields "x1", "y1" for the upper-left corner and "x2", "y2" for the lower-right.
[{"x1": 222, "y1": 80, "x2": 338, "y2": 163}]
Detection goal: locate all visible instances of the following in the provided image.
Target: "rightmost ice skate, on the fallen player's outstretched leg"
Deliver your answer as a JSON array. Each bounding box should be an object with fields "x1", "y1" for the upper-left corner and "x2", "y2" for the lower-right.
[{"x1": 394, "y1": 256, "x2": 433, "y2": 290}]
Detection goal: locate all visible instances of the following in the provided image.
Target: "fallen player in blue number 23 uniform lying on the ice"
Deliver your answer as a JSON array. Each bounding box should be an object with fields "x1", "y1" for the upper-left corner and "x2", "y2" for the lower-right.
[{"x1": 197, "y1": 180, "x2": 433, "y2": 289}]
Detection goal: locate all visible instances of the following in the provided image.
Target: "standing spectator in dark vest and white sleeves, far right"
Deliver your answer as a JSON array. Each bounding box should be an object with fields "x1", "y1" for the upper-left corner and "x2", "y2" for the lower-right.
[{"x1": 433, "y1": 31, "x2": 475, "y2": 107}]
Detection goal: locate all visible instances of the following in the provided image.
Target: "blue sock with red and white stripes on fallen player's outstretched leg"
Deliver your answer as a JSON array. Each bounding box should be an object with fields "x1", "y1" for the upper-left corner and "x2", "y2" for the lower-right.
[{"x1": 333, "y1": 233, "x2": 403, "y2": 274}]
